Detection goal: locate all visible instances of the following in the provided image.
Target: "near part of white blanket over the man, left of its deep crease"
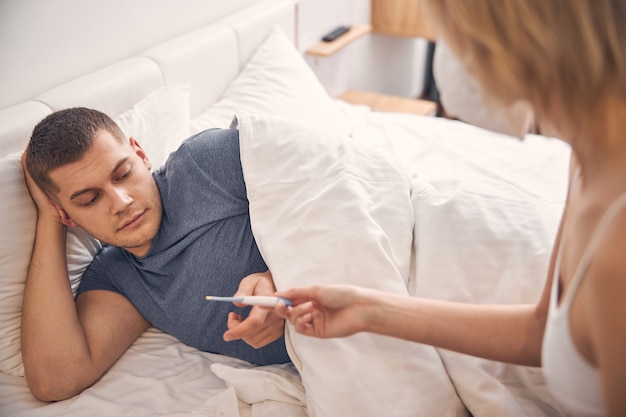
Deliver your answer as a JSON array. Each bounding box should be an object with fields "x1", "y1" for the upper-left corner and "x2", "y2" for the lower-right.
[{"x1": 238, "y1": 116, "x2": 463, "y2": 416}]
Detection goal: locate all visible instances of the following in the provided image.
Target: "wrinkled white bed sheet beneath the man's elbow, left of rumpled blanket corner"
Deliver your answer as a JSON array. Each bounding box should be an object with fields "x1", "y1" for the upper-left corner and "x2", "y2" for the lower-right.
[{"x1": 0, "y1": 329, "x2": 232, "y2": 417}]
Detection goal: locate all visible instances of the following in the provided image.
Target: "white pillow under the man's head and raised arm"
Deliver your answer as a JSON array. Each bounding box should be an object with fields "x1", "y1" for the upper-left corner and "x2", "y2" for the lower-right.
[{"x1": 0, "y1": 86, "x2": 189, "y2": 376}]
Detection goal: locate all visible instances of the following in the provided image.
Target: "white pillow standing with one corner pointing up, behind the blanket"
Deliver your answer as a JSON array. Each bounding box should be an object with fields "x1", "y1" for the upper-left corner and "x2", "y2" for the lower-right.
[{"x1": 192, "y1": 27, "x2": 349, "y2": 135}]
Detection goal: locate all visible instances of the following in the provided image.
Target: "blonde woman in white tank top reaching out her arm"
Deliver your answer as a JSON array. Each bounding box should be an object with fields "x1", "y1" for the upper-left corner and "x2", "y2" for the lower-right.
[{"x1": 277, "y1": 0, "x2": 626, "y2": 416}]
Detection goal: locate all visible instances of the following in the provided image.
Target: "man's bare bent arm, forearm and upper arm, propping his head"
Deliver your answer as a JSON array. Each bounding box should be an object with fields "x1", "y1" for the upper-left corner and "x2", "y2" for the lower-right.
[{"x1": 21, "y1": 213, "x2": 149, "y2": 401}]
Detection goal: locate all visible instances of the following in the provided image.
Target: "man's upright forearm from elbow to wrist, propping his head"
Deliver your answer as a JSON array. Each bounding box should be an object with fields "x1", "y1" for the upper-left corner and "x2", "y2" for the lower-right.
[{"x1": 21, "y1": 219, "x2": 94, "y2": 400}]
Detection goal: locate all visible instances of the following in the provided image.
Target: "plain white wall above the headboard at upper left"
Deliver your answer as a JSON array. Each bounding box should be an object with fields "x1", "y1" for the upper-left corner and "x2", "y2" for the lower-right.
[{"x1": 0, "y1": 0, "x2": 256, "y2": 109}]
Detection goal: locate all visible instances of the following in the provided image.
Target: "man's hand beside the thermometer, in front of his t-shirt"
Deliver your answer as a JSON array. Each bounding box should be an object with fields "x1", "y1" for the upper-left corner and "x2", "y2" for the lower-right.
[{"x1": 224, "y1": 271, "x2": 285, "y2": 349}]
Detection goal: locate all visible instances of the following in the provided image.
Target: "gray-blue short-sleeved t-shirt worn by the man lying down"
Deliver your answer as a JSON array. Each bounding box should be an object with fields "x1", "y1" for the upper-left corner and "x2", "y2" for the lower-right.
[{"x1": 78, "y1": 129, "x2": 289, "y2": 365}]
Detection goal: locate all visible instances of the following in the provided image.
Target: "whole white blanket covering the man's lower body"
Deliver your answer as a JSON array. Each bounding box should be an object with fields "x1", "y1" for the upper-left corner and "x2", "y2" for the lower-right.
[{"x1": 233, "y1": 111, "x2": 568, "y2": 416}]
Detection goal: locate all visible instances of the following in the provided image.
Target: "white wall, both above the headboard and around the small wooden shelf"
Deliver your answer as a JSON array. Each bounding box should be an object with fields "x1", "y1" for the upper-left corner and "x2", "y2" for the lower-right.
[{"x1": 0, "y1": 0, "x2": 425, "y2": 109}]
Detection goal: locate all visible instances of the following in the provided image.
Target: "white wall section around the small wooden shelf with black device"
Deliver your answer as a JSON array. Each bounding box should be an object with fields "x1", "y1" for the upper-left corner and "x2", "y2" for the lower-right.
[{"x1": 298, "y1": 0, "x2": 426, "y2": 97}]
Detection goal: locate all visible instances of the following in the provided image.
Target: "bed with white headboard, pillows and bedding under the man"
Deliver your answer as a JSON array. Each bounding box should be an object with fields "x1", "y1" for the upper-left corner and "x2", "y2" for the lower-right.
[{"x1": 0, "y1": 0, "x2": 569, "y2": 417}]
